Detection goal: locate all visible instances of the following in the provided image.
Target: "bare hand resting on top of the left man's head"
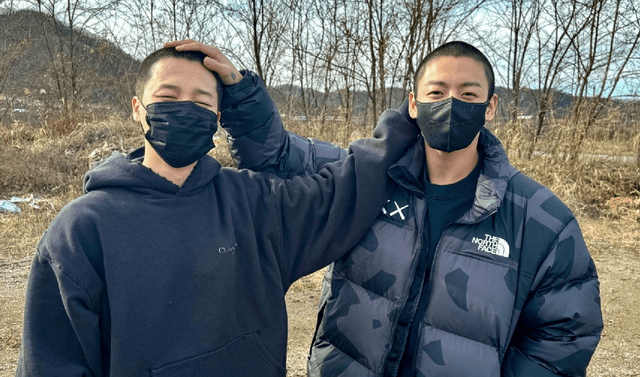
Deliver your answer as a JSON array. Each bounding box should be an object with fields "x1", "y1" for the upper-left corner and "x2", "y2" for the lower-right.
[{"x1": 163, "y1": 39, "x2": 242, "y2": 86}]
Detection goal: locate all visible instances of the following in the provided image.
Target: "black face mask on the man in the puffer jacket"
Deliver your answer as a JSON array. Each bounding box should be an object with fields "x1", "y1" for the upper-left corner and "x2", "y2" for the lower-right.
[{"x1": 416, "y1": 97, "x2": 489, "y2": 152}]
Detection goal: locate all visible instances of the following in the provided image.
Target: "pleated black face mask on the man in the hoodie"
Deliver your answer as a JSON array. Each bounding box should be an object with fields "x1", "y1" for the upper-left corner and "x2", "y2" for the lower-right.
[{"x1": 141, "y1": 101, "x2": 218, "y2": 168}]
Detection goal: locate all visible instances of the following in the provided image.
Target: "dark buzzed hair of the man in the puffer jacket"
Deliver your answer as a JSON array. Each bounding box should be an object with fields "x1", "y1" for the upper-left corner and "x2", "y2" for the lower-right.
[{"x1": 413, "y1": 41, "x2": 495, "y2": 100}]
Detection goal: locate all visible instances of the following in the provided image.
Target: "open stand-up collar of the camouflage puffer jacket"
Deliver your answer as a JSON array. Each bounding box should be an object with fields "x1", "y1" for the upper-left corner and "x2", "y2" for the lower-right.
[{"x1": 389, "y1": 127, "x2": 518, "y2": 223}]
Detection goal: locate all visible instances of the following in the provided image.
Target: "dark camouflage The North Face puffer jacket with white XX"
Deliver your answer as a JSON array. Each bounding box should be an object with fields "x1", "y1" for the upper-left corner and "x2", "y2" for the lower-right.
[{"x1": 222, "y1": 73, "x2": 603, "y2": 377}]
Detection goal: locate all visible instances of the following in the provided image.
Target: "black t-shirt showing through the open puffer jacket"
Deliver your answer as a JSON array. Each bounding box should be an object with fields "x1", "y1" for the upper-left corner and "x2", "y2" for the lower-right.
[{"x1": 398, "y1": 156, "x2": 482, "y2": 377}]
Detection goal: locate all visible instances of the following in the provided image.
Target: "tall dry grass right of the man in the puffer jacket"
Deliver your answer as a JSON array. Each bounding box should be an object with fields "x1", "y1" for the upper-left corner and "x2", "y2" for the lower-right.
[{"x1": 493, "y1": 116, "x2": 640, "y2": 219}]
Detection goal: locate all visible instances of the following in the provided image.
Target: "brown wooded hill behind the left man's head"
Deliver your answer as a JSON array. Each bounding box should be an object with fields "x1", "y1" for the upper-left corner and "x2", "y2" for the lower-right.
[{"x1": 0, "y1": 10, "x2": 139, "y2": 115}]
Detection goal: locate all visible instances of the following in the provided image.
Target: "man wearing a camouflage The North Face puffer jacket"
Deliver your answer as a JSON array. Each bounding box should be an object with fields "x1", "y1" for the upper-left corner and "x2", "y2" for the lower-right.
[{"x1": 222, "y1": 42, "x2": 603, "y2": 377}]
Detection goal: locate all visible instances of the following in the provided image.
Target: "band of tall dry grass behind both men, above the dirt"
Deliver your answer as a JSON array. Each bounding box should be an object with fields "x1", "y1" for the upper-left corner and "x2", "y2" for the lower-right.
[{"x1": 0, "y1": 108, "x2": 640, "y2": 212}]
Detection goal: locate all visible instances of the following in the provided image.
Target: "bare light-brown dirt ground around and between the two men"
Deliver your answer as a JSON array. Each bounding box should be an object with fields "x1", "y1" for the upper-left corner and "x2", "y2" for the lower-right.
[{"x1": 0, "y1": 213, "x2": 640, "y2": 377}]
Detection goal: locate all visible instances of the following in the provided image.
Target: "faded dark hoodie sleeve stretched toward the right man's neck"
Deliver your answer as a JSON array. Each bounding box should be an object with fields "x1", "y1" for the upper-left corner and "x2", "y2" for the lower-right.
[{"x1": 272, "y1": 110, "x2": 418, "y2": 283}]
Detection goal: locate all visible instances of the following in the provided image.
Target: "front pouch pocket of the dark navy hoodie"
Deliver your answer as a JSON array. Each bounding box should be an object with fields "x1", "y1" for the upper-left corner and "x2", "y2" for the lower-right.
[{"x1": 151, "y1": 333, "x2": 285, "y2": 377}]
